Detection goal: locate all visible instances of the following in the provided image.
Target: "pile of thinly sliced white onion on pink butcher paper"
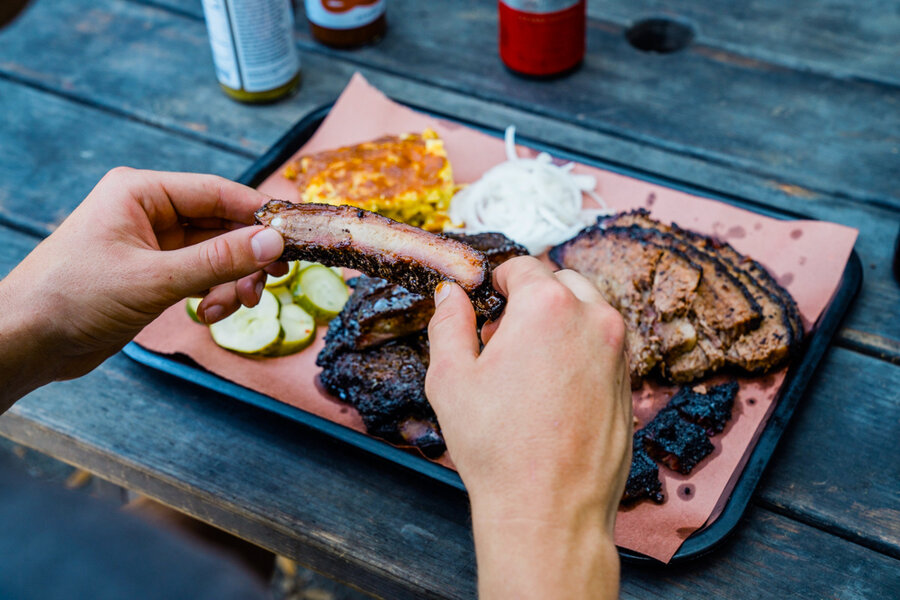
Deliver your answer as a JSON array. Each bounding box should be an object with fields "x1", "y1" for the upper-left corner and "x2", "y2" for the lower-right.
[{"x1": 448, "y1": 125, "x2": 612, "y2": 254}]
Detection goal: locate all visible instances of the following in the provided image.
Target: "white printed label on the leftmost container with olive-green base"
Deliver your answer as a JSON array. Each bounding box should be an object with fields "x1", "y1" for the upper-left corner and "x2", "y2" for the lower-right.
[{"x1": 203, "y1": 0, "x2": 300, "y2": 92}]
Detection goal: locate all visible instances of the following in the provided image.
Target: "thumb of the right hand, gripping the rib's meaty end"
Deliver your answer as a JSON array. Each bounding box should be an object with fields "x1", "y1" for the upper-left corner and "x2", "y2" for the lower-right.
[{"x1": 426, "y1": 281, "x2": 479, "y2": 398}]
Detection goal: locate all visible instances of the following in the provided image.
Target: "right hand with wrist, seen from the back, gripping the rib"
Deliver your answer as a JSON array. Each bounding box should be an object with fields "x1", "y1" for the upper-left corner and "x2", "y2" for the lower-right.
[{"x1": 425, "y1": 257, "x2": 632, "y2": 598}]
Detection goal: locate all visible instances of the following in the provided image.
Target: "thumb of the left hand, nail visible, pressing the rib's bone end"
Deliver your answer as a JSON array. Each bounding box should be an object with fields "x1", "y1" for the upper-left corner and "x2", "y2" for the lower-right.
[{"x1": 164, "y1": 227, "x2": 284, "y2": 299}]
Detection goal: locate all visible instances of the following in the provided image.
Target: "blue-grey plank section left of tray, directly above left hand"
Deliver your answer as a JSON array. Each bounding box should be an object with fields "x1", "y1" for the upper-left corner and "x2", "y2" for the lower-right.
[{"x1": 0, "y1": 80, "x2": 250, "y2": 233}]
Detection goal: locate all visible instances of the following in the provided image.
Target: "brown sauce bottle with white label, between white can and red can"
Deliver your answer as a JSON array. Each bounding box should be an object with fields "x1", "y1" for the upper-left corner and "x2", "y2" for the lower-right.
[{"x1": 305, "y1": 0, "x2": 387, "y2": 48}]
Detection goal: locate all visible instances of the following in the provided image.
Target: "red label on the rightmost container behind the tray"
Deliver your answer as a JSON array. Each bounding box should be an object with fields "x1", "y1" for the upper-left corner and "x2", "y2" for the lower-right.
[{"x1": 498, "y1": 0, "x2": 586, "y2": 76}]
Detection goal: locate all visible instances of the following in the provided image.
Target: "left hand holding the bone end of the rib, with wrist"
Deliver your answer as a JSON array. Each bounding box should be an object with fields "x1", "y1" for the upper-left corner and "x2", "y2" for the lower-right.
[{"x1": 0, "y1": 168, "x2": 284, "y2": 404}]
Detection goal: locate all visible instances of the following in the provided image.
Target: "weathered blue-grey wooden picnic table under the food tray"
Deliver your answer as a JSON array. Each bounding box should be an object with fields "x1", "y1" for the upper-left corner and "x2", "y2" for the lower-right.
[{"x1": 0, "y1": 0, "x2": 900, "y2": 599}]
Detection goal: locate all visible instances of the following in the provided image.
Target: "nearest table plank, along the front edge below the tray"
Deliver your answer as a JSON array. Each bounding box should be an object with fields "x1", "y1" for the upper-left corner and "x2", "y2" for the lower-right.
[{"x1": 0, "y1": 344, "x2": 898, "y2": 598}]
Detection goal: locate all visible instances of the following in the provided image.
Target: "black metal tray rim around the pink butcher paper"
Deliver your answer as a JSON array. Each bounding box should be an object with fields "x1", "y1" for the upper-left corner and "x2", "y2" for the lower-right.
[{"x1": 124, "y1": 104, "x2": 862, "y2": 564}]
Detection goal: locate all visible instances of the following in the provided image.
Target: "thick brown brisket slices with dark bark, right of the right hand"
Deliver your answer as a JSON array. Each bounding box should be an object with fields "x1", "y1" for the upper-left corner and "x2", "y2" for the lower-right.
[{"x1": 550, "y1": 209, "x2": 803, "y2": 384}]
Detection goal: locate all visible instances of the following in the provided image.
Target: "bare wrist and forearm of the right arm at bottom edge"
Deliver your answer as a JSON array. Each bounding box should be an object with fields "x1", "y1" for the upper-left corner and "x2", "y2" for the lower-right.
[{"x1": 472, "y1": 492, "x2": 619, "y2": 600}]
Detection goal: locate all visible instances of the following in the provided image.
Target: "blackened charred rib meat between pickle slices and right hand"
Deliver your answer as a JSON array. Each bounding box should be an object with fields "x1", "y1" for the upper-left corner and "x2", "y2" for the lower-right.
[{"x1": 316, "y1": 335, "x2": 444, "y2": 456}]
